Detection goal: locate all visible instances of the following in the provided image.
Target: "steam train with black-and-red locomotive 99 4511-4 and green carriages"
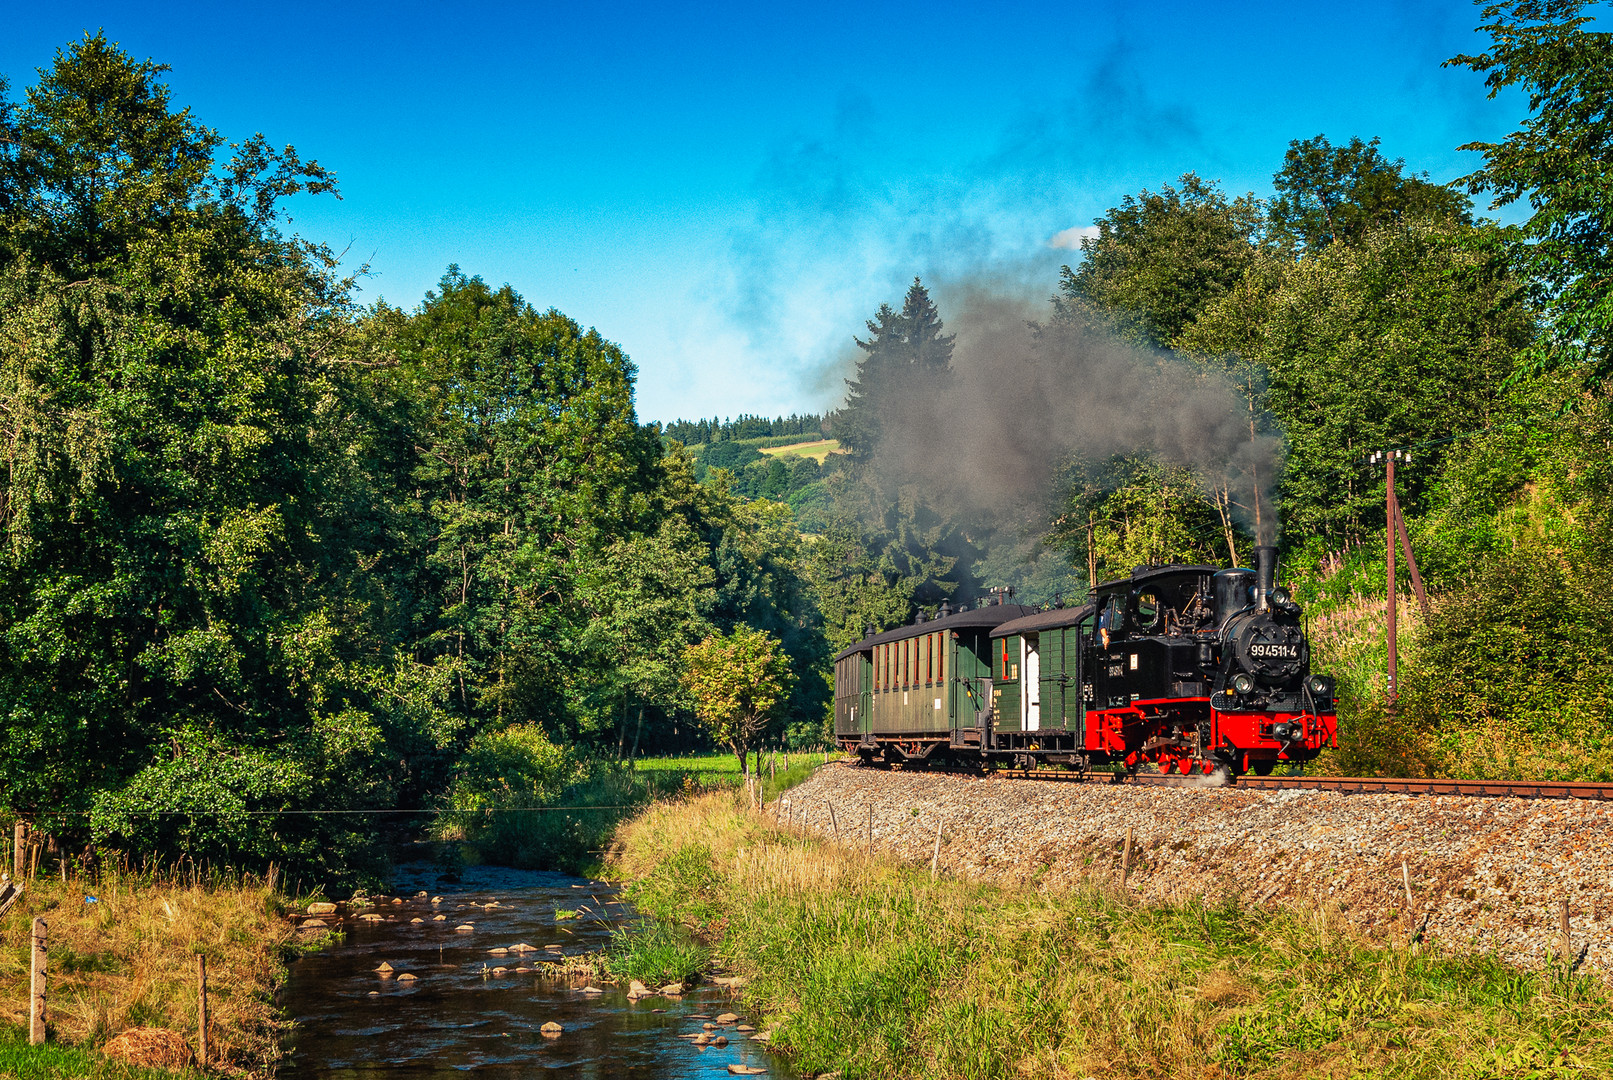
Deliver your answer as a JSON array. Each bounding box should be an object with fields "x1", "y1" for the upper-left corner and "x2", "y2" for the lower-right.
[{"x1": 834, "y1": 546, "x2": 1337, "y2": 779}]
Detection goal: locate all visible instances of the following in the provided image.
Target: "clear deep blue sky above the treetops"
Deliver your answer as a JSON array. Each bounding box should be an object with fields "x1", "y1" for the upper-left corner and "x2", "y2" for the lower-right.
[{"x1": 0, "y1": 0, "x2": 1521, "y2": 419}]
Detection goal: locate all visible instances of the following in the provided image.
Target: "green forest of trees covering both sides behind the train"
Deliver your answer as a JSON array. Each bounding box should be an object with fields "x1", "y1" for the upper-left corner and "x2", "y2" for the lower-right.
[{"x1": 0, "y1": 5, "x2": 1613, "y2": 879}]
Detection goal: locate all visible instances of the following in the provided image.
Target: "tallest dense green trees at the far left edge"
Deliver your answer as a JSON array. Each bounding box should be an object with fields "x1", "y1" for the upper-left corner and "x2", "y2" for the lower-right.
[{"x1": 0, "y1": 35, "x2": 422, "y2": 866}]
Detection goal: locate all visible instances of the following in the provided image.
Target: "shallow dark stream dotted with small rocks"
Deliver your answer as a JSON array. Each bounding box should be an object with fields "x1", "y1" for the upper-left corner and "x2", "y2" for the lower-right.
[{"x1": 279, "y1": 866, "x2": 797, "y2": 1080}]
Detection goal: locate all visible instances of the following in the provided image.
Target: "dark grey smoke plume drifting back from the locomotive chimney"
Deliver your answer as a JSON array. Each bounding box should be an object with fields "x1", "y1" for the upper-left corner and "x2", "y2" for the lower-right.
[{"x1": 873, "y1": 292, "x2": 1282, "y2": 543}]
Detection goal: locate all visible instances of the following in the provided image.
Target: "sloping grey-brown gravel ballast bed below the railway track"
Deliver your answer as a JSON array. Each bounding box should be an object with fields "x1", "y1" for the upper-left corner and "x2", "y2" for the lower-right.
[{"x1": 769, "y1": 764, "x2": 1613, "y2": 977}]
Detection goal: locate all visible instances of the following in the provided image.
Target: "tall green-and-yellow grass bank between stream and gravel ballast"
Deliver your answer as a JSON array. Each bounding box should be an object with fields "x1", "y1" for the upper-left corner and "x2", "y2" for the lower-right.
[{"x1": 613, "y1": 793, "x2": 1613, "y2": 1080}]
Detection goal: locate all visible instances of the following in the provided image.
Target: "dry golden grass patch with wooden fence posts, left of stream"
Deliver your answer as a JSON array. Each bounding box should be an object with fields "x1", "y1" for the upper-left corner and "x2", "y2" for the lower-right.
[{"x1": 0, "y1": 869, "x2": 295, "y2": 1078}]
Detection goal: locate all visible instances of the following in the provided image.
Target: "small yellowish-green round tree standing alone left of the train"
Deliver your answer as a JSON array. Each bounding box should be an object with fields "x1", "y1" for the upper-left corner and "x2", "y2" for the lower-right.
[{"x1": 682, "y1": 625, "x2": 795, "y2": 775}]
